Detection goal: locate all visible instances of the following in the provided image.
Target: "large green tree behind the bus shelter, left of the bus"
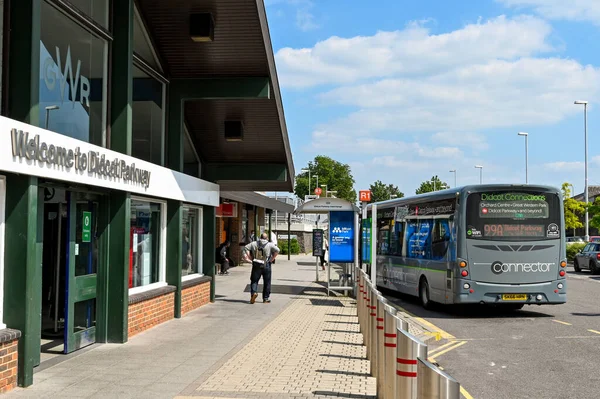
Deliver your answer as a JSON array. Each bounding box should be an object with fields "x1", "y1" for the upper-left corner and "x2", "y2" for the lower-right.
[{"x1": 294, "y1": 155, "x2": 356, "y2": 203}]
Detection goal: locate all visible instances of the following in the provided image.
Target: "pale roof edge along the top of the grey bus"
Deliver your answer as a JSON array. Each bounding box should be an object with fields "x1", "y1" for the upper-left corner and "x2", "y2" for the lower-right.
[{"x1": 367, "y1": 184, "x2": 562, "y2": 209}]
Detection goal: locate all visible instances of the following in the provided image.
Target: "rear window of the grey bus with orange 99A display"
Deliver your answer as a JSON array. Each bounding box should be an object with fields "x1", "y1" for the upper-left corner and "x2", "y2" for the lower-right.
[{"x1": 467, "y1": 191, "x2": 561, "y2": 241}]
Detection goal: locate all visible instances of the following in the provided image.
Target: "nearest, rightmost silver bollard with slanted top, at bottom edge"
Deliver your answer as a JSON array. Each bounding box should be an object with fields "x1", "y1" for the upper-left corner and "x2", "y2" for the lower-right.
[{"x1": 417, "y1": 357, "x2": 460, "y2": 399}]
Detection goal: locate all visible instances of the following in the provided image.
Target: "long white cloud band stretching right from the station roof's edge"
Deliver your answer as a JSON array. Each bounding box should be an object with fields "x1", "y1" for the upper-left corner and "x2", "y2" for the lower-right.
[{"x1": 276, "y1": 16, "x2": 553, "y2": 88}]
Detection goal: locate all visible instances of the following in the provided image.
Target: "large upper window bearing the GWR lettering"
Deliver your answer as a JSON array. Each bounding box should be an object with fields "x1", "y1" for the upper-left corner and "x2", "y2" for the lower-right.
[{"x1": 39, "y1": 1, "x2": 108, "y2": 146}]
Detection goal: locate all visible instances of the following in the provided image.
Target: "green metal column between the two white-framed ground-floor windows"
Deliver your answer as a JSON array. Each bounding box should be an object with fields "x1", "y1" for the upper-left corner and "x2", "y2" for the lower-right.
[{"x1": 167, "y1": 200, "x2": 183, "y2": 318}]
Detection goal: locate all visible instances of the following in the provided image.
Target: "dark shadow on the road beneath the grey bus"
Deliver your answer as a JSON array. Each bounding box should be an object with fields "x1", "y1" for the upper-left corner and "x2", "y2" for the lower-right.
[{"x1": 380, "y1": 288, "x2": 555, "y2": 319}]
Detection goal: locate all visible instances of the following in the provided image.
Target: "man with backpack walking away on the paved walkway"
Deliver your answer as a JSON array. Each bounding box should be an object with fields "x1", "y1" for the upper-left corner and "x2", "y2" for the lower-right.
[{"x1": 243, "y1": 233, "x2": 279, "y2": 304}]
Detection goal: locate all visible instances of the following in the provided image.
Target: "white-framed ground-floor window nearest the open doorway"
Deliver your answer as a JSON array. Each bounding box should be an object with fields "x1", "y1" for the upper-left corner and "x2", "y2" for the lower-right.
[{"x1": 129, "y1": 198, "x2": 166, "y2": 293}]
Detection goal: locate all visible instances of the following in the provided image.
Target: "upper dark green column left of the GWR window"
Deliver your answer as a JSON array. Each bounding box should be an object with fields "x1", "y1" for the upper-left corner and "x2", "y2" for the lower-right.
[{"x1": 6, "y1": 0, "x2": 43, "y2": 126}]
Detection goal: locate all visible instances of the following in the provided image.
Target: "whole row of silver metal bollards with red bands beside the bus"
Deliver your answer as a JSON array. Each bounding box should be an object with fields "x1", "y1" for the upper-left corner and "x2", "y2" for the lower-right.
[{"x1": 355, "y1": 268, "x2": 460, "y2": 399}]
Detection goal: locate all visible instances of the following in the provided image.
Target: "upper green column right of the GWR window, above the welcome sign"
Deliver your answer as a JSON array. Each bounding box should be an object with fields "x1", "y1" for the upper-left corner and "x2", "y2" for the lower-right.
[{"x1": 110, "y1": 0, "x2": 134, "y2": 155}]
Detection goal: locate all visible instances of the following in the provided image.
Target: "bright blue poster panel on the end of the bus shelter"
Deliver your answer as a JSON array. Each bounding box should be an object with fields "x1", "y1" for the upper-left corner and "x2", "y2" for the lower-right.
[{"x1": 329, "y1": 211, "x2": 354, "y2": 263}]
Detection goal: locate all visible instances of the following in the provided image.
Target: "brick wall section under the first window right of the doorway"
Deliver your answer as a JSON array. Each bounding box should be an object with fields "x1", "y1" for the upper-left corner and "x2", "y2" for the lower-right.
[{"x1": 128, "y1": 287, "x2": 175, "y2": 338}]
